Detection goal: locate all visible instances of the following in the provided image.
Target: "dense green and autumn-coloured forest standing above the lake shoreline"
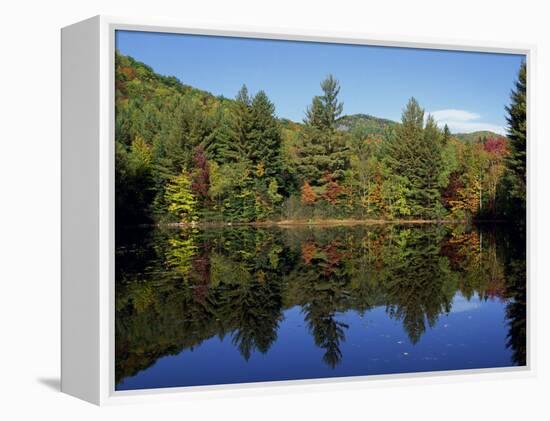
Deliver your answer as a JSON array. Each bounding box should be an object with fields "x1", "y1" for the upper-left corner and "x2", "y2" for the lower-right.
[{"x1": 115, "y1": 52, "x2": 526, "y2": 226}]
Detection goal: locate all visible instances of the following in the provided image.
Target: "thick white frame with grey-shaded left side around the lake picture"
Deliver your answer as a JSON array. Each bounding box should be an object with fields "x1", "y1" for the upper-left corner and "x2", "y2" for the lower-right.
[{"x1": 61, "y1": 16, "x2": 536, "y2": 405}]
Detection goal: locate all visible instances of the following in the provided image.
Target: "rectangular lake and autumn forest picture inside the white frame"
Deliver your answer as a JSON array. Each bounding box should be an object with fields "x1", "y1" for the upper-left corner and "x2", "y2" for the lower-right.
[{"x1": 114, "y1": 31, "x2": 527, "y2": 390}]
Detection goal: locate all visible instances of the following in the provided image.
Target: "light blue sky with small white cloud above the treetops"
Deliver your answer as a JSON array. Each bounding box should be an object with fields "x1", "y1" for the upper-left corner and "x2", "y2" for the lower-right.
[{"x1": 116, "y1": 31, "x2": 524, "y2": 133}]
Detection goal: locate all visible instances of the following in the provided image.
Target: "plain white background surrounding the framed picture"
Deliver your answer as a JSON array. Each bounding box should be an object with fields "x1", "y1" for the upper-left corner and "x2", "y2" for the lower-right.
[{"x1": 0, "y1": 0, "x2": 550, "y2": 420}]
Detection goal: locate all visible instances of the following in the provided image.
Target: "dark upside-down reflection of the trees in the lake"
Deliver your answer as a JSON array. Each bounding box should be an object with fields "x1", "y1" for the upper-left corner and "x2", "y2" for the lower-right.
[{"x1": 116, "y1": 225, "x2": 526, "y2": 384}]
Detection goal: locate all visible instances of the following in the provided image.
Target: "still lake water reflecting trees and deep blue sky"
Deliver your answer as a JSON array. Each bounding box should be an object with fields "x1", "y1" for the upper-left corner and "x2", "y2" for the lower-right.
[{"x1": 115, "y1": 225, "x2": 526, "y2": 390}]
